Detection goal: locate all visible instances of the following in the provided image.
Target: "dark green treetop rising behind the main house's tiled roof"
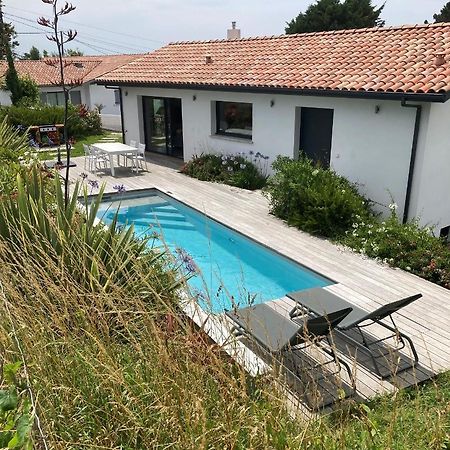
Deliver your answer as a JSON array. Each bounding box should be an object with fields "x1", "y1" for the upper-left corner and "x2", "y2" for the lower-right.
[{"x1": 285, "y1": 0, "x2": 385, "y2": 34}]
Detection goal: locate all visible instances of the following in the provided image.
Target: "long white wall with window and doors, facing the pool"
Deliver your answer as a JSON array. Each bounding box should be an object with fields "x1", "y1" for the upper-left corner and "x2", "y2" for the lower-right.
[{"x1": 123, "y1": 88, "x2": 415, "y2": 220}]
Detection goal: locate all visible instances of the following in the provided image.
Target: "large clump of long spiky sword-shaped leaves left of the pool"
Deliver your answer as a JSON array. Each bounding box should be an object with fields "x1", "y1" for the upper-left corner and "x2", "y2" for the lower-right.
[{"x1": 0, "y1": 170, "x2": 176, "y2": 301}]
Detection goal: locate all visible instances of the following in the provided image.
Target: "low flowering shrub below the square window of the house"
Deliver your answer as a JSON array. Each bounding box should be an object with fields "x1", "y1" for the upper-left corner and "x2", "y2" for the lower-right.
[{"x1": 181, "y1": 153, "x2": 268, "y2": 190}]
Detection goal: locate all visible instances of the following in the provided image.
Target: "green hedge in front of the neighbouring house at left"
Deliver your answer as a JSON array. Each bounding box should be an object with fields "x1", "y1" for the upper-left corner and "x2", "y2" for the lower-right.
[{"x1": 0, "y1": 105, "x2": 101, "y2": 139}]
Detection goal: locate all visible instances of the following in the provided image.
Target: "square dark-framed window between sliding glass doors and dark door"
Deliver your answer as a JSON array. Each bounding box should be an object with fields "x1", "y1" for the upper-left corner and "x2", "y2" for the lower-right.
[{"x1": 216, "y1": 102, "x2": 253, "y2": 139}]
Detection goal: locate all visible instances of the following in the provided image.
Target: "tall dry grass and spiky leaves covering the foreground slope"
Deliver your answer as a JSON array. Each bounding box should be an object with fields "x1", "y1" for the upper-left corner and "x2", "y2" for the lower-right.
[{"x1": 0, "y1": 170, "x2": 450, "y2": 450}]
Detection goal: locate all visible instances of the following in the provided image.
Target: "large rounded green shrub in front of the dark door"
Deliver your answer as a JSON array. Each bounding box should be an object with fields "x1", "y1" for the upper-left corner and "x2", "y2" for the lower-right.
[{"x1": 265, "y1": 156, "x2": 372, "y2": 238}]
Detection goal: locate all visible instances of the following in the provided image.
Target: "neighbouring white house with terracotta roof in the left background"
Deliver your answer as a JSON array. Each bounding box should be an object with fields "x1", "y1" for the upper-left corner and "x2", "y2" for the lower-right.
[{"x1": 0, "y1": 55, "x2": 137, "y2": 130}]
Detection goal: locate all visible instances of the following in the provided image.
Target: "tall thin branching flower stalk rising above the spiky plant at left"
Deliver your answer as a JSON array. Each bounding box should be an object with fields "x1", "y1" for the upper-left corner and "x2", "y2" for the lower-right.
[{"x1": 38, "y1": 0, "x2": 78, "y2": 208}]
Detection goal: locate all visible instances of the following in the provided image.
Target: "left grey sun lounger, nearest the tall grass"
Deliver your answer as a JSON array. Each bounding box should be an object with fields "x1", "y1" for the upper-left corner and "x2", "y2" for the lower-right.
[{"x1": 226, "y1": 303, "x2": 353, "y2": 388}]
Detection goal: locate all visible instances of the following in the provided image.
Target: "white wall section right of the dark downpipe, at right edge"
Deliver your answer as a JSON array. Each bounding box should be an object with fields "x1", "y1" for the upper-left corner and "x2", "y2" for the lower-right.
[{"x1": 410, "y1": 101, "x2": 450, "y2": 235}]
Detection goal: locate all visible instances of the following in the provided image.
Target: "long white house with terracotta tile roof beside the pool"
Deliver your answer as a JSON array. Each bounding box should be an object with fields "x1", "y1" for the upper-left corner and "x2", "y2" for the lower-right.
[{"x1": 97, "y1": 24, "x2": 450, "y2": 235}]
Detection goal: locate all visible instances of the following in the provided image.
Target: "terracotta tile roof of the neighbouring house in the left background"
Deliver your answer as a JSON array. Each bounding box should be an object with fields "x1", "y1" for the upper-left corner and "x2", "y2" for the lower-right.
[{"x1": 0, "y1": 55, "x2": 142, "y2": 86}]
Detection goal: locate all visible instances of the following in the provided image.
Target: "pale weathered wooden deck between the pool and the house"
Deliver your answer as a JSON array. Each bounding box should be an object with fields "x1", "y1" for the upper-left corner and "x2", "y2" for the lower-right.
[{"x1": 67, "y1": 156, "x2": 450, "y2": 406}]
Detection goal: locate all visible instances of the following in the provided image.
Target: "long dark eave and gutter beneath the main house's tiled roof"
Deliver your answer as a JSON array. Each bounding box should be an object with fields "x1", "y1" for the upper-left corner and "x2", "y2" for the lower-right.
[{"x1": 94, "y1": 80, "x2": 450, "y2": 103}]
